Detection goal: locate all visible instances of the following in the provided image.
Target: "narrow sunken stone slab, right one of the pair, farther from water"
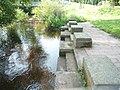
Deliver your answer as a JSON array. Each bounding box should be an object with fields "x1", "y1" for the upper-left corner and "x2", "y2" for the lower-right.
[{"x1": 66, "y1": 53, "x2": 77, "y2": 72}]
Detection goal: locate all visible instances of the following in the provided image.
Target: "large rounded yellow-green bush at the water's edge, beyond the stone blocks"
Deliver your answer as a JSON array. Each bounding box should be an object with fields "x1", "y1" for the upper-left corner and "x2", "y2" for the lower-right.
[{"x1": 33, "y1": 0, "x2": 67, "y2": 28}]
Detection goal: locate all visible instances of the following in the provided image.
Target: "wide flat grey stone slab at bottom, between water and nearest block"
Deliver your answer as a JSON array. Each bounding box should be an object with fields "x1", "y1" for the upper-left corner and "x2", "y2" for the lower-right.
[{"x1": 55, "y1": 71, "x2": 81, "y2": 90}]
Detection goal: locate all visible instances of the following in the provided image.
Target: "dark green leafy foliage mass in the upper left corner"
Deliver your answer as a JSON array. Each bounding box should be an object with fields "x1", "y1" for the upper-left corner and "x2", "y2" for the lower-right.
[{"x1": 0, "y1": 0, "x2": 16, "y2": 26}]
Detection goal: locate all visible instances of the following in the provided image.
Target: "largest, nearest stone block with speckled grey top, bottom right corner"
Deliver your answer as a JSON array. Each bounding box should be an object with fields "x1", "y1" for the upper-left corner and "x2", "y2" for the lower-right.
[{"x1": 83, "y1": 56, "x2": 120, "y2": 90}]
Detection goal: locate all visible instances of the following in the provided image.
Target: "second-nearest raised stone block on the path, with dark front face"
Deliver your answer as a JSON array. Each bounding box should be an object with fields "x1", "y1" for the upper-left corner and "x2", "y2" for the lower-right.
[{"x1": 73, "y1": 33, "x2": 92, "y2": 48}]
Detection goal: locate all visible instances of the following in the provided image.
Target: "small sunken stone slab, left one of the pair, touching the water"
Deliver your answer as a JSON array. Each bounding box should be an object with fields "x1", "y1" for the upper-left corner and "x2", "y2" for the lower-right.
[{"x1": 57, "y1": 57, "x2": 67, "y2": 71}]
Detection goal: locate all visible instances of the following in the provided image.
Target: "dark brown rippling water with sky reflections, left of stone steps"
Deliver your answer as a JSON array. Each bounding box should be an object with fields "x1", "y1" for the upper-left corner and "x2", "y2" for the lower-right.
[{"x1": 0, "y1": 24, "x2": 59, "y2": 90}]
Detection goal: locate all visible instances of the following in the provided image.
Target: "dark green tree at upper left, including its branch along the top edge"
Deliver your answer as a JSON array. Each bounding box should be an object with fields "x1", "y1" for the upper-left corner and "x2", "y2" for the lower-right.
[{"x1": 0, "y1": 0, "x2": 31, "y2": 26}]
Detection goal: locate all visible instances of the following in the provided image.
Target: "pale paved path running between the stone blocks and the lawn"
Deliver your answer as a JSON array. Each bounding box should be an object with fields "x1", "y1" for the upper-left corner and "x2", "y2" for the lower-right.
[{"x1": 74, "y1": 22, "x2": 120, "y2": 70}]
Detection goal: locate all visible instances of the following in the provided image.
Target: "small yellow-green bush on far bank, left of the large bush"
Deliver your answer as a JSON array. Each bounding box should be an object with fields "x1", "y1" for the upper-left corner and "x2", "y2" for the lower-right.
[{"x1": 16, "y1": 9, "x2": 29, "y2": 22}]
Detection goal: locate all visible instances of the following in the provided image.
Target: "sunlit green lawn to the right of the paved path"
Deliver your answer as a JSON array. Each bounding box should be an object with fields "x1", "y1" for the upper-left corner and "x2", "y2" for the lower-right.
[{"x1": 66, "y1": 3, "x2": 120, "y2": 38}]
